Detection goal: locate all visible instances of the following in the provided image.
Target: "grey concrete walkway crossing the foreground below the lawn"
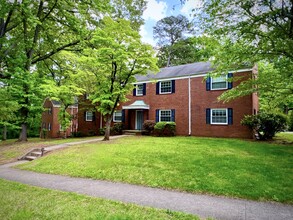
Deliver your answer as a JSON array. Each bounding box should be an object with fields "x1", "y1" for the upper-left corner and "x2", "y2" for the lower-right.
[{"x1": 0, "y1": 137, "x2": 293, "y2": 220}]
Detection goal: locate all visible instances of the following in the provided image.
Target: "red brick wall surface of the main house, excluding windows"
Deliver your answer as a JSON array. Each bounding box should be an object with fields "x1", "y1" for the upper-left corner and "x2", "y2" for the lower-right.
[{"x1": 120, "y1": 72, "x2": 257, "y2": 138}]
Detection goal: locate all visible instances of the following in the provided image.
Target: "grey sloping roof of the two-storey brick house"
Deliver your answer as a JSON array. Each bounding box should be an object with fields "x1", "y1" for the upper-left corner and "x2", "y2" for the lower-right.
[{"x1": 136, "y1": 62, "x2": 213, "y2": 82}]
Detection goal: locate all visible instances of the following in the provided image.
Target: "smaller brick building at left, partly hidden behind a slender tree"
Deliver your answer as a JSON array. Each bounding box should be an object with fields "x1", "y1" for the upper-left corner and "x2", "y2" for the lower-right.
[{"x1": 40, "y1": 98, "x2": 78, "y2": 138}]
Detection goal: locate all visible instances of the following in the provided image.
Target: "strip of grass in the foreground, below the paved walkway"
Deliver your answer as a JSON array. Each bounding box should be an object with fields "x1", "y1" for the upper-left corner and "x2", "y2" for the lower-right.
[{"x1": 0, "y1": 179, "x2": 198, "y2": 220}]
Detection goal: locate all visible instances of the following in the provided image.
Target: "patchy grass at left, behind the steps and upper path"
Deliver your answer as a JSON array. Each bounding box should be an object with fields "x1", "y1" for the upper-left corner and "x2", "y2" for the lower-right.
[{"x1": 0, "y1": 137, "x2": 97, "y2": 164}]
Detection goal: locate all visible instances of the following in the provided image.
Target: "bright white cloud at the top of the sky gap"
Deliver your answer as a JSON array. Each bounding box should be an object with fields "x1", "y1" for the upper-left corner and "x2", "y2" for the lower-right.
[{"x1": 142, "y1": 0, "x2": 168, "y2": 21}]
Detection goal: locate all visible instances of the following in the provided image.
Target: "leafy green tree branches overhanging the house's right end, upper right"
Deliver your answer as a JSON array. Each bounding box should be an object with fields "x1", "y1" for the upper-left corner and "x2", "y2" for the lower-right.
[{"x1": 201, "y1": 0, "x2": 293, "y2": 110}]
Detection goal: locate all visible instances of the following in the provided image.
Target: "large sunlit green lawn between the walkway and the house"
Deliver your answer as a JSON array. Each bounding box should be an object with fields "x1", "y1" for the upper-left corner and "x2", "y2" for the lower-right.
[{"x1": 20, "y1": 137, "x2": 293, "y2": 203}]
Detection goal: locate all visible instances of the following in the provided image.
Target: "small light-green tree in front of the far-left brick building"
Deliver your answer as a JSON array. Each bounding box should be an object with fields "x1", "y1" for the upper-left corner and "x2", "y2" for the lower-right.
[{"x1": 39, "y1": 51, "x2": 85, "y2": 138}]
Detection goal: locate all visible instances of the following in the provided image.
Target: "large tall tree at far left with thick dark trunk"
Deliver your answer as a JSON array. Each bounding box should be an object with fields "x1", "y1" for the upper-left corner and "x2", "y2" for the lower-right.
[{"x1": 0, "y1": 0, "x2": 108, "y2": 141}]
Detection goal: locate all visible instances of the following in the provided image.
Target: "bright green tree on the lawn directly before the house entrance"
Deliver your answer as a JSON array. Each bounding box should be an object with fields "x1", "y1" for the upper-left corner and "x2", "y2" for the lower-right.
[{"x1": 80, "y1": 17, "x2": 158, "y2": 140}]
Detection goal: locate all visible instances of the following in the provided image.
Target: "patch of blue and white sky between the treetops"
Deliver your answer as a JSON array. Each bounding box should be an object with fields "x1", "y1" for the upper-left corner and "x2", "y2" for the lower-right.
[{"x1": 140, "y1": 0, "x2": 201, "y2": 46}]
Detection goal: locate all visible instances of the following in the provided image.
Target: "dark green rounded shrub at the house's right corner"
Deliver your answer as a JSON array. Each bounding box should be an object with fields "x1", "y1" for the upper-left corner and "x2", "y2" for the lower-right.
[{"x1": 241, "y1": 113, "x2": 287, "y2": 140}]
